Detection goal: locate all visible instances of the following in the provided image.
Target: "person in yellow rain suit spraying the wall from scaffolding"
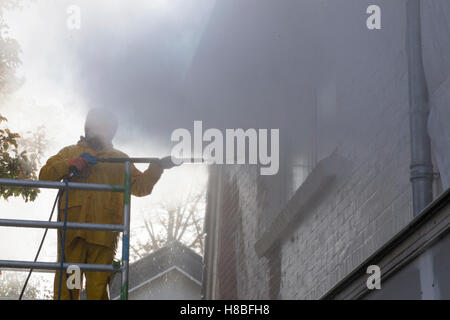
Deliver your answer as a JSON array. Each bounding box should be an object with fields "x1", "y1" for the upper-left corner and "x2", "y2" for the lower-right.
[{"x1": 39, "y1": 108, "x2": 165, "y2": 300}]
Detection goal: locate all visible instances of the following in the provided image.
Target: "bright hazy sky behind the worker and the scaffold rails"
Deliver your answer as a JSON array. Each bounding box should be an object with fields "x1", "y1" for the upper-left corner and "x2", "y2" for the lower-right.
[{"x1": 0, "y1": 0, "x2": 214, "y2": 296}]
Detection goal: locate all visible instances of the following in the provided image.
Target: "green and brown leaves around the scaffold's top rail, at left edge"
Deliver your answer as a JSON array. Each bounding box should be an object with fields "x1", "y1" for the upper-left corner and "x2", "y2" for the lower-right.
[{"x1": 0, "y1": 114, "x2": 44, "y2": 202}]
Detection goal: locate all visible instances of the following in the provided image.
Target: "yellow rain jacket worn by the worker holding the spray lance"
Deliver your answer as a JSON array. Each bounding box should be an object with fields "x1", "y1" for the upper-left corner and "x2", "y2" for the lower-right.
[{"x1": 39, "y1": 140, "x2": 164, "y2": 251}]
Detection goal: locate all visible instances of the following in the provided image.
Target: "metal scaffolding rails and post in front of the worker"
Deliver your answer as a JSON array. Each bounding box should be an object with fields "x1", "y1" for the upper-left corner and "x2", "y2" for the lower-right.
[{"x1": 0, "y1": 158, "x2": 133, "y2": 300}]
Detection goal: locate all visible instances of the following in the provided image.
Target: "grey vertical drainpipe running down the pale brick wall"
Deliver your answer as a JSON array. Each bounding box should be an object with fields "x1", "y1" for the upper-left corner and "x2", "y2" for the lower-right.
[{"x1": 406, "y1": 0, "x2": 433, "y2": 217}]
